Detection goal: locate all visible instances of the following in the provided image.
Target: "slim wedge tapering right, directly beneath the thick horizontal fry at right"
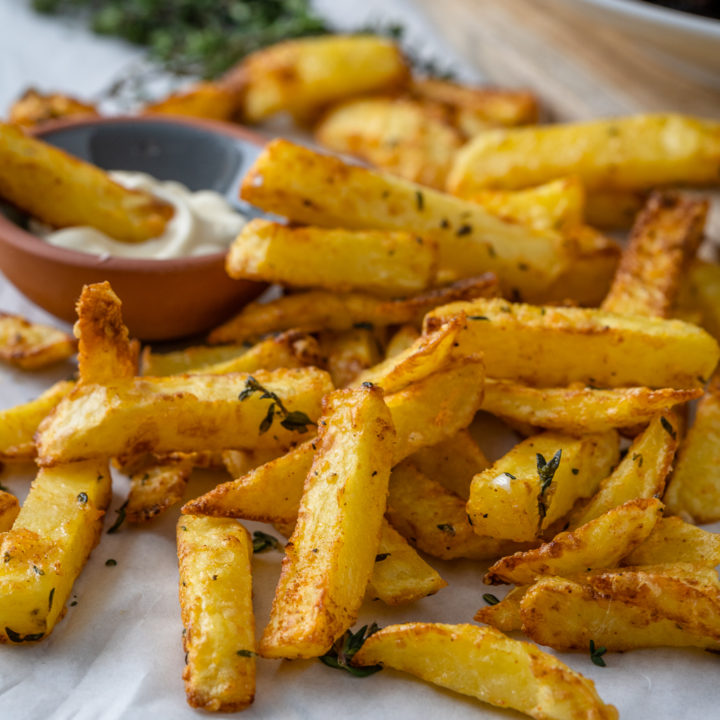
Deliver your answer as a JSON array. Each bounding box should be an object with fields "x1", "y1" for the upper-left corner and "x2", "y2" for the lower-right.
[{"x1": 482, "y1": 378, "x2": 702, "y2": 433}]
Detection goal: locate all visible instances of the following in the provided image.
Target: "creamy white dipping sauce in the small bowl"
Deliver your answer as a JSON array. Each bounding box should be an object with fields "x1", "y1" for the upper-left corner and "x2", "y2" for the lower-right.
[{"x1": 30, "y1": 170, "x2": 247, "y2": 260}]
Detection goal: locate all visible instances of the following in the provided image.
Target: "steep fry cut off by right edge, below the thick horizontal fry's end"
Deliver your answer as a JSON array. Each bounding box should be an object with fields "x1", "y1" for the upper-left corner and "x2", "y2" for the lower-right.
[{"x1": 663, "y1": 374, "x2": 720, "y2": 523}]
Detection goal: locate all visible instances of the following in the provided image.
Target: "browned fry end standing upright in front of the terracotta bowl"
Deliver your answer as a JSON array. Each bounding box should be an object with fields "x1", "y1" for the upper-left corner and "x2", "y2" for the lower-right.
[{"x1": 73, "y1": 282, "x2": 138, "y2": 385}]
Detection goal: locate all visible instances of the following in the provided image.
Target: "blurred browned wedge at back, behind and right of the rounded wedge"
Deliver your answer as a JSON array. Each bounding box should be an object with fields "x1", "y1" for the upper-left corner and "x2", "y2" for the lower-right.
[{"x1": 410, "y1": 77, "x2": 539, "y2": 131}]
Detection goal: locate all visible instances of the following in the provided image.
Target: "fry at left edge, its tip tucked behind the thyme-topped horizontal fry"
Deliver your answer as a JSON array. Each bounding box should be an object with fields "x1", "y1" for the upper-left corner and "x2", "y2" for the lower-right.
[{"x1": 0, "y1": 380, "x2": 75, "y2": 462}]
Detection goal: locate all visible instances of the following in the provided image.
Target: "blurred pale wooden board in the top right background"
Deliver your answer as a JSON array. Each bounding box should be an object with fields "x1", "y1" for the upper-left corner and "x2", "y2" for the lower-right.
[{"x1": 416, "y1": 0, "x2": 720, "y2": 120}]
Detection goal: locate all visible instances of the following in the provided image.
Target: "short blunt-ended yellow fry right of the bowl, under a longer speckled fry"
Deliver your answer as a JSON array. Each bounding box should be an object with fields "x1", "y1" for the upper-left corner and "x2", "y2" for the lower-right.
[{"x1": 225, "y1": 219, "x2": 438, "y2": 298}]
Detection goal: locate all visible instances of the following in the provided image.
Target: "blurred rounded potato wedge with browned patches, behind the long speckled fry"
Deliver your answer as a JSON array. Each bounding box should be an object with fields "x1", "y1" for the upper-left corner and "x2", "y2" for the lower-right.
[{"x1": 315, "y1": 97, "x2": 463, "y2": 189}]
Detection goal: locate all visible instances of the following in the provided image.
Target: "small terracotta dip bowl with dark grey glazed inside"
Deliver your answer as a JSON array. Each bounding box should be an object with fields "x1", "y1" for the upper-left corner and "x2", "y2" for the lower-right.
[{"x1": 0, "y1": 116, "x2": 265, "y2": 340}]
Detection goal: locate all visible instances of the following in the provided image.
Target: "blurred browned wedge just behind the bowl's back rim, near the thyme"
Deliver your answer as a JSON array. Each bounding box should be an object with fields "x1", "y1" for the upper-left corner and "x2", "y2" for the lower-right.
[{"x1": 143, "y1": 82, "x2": 242, "y2": 122}]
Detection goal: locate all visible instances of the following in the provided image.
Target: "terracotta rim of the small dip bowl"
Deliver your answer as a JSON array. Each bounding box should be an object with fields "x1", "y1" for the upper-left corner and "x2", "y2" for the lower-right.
[{"x1": 0, "y1": 114, "x2": 267, "y2": 273}]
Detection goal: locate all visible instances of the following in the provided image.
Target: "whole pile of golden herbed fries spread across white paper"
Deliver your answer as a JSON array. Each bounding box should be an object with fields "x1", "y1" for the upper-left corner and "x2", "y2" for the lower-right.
[{"x1": 0, "y1": 31, "x2": 720, "y2": 720}]
